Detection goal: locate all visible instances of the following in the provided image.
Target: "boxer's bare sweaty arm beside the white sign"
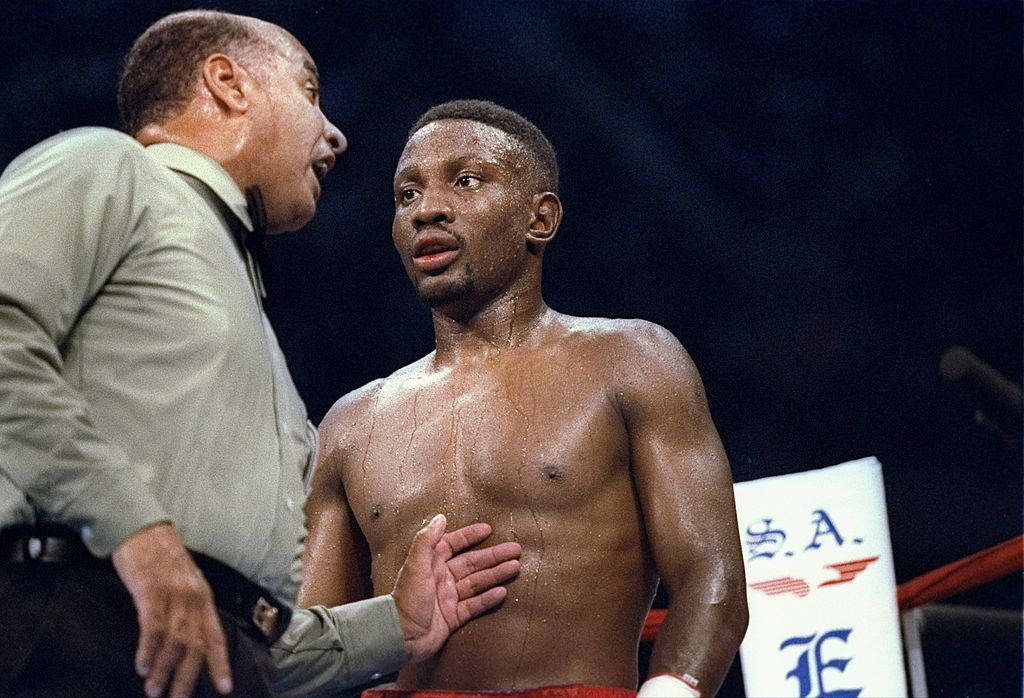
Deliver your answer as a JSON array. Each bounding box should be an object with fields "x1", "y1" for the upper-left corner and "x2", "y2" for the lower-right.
[{"x1": 617, "y1": 322, "x2": 748, "y2": 696}]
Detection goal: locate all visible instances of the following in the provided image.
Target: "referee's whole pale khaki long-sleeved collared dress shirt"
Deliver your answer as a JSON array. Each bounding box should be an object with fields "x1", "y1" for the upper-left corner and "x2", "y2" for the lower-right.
[{"x1": 0, "y1": 128, "x2": 402, "y2": 695}]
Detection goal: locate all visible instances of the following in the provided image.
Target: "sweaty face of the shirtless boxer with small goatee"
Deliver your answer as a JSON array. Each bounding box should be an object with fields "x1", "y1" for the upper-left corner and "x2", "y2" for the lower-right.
[{"x1": 391, "y1": 119, "x2": 530, "y2": 306}]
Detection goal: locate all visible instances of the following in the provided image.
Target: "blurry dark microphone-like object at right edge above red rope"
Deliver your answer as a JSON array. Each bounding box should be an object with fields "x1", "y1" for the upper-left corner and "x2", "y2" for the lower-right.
[{"x1": 939, "y1": 347, "x2": 1024, "y2": 445}]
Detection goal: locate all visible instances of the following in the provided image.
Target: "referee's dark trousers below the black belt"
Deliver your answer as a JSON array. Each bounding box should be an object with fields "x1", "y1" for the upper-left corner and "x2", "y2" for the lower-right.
[{"x1": 0, "y1": 560, "x2": 272, "y2": 698}]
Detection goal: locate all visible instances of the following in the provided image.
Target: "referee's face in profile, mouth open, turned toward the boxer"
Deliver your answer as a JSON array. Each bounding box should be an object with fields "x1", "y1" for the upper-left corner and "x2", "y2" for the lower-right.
[{"x1": 245, "y1": 26, "x2": 347, "y2": 232}]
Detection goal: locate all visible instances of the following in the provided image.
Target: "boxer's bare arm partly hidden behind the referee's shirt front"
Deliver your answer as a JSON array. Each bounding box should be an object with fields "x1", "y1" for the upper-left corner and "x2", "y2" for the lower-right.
[{"x1": 298, "y1": 389, "x2": 373, "y2": 607}]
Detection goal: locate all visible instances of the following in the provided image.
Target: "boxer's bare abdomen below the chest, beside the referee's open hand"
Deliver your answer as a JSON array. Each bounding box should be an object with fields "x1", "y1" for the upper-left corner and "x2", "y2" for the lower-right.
[{"x1": 399, "y1": 511, "x2": 655, "y2": 690}]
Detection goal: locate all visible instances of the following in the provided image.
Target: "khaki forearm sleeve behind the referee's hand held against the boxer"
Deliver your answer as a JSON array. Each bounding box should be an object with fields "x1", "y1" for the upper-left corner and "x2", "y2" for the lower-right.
[{"x1": 270, "y1": 595, "x2": 406, "y2": 698}]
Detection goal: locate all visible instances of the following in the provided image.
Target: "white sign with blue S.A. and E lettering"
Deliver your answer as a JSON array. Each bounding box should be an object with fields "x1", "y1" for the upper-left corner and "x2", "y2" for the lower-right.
[{"x1": 735, "y1": 457, "x2": 906, "y2": 698}]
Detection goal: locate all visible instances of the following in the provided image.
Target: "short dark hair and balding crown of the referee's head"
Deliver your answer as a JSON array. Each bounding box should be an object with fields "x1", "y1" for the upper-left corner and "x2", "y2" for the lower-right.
[{"x1": 118, "y1": 10, "x2": 298, "y2": 135}]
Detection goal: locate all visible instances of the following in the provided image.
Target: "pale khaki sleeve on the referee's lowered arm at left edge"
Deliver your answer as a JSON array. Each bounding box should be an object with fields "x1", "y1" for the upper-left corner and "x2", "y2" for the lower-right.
[{"x1": 0, "y1": 129, "x2": 168, "y2": 557}]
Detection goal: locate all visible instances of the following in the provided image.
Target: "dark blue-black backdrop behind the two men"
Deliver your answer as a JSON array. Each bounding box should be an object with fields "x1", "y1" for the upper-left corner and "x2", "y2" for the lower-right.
[{"x1": 0, "y1": 0, "x2": 1022, "y2": 691}]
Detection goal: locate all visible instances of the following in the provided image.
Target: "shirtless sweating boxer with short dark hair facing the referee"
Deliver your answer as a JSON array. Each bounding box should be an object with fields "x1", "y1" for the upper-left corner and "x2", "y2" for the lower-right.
[{"x1": 300, "y1": 100, "x2": 746, "y2": 695}]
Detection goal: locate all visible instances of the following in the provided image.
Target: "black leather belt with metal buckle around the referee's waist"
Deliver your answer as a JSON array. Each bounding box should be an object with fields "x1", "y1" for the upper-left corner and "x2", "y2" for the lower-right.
[{"x1": 0, "y1": 524, "x2": 292, "y2": 645}]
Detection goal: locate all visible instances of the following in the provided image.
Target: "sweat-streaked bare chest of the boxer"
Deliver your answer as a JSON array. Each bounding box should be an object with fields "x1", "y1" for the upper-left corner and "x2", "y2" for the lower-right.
[{"x1": 345, "y1": 366, "x2": 629, "y2": 547}]
